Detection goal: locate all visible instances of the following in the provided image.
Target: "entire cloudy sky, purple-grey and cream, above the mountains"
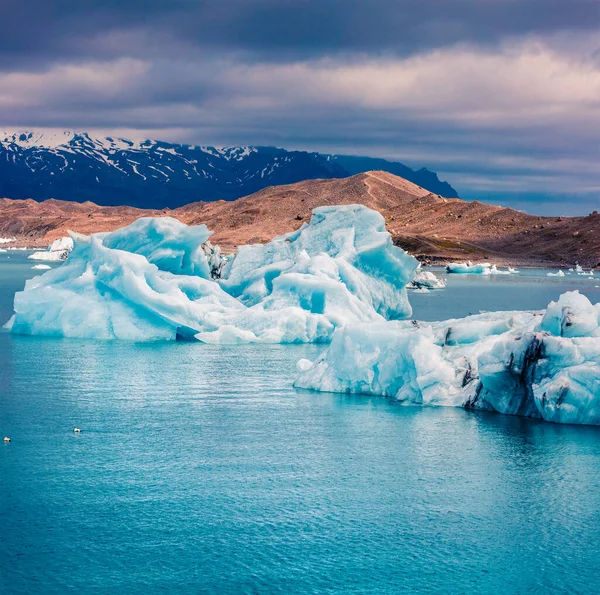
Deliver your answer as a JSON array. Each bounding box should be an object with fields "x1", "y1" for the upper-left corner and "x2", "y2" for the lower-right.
[{"x1": 0, "y1": 0, "x2": 600, "y2": 214}]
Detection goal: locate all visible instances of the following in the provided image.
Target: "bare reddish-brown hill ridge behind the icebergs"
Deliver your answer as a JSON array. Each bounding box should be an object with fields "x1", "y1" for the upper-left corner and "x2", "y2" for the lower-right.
[{"x1": 0, "y1": 172, "x2": 600, "y2": 266}]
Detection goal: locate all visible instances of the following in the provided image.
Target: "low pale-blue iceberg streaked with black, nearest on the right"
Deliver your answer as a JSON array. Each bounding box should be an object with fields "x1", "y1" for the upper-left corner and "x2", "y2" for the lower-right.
[{"x1": 295, "y1": 292, "x2": 600, "y2": 425}]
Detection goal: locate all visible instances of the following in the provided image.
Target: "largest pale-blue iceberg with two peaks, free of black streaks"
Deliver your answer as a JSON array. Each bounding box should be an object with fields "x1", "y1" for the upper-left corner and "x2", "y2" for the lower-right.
[{"x1": 10, "y1": 205, "x2": 417, "y2": 343}]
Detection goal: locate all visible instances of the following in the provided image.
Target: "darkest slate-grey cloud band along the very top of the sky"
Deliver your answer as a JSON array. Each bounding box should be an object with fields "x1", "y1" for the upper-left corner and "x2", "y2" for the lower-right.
[{"x1": 0, "y1": 0, "x2": 600, "y2": 65}]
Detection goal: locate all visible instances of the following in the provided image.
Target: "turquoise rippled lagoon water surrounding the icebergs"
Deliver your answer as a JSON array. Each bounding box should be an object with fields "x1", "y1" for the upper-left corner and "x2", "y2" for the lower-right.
[{"x1": 0, "y1": 253, "x2": 600, "y2": 594}]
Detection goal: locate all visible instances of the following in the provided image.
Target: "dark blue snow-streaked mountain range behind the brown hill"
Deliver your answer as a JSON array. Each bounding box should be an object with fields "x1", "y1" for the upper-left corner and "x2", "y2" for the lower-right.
[{"x1": 0, "y1": 131, "x2": 458, "y2": 208}]
